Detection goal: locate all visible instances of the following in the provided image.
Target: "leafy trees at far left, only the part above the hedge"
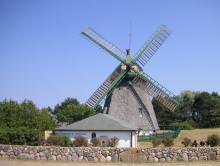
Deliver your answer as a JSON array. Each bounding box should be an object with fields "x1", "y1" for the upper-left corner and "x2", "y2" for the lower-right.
[{"x1": 0, "y1": 100, "x2": 56, "y2": 131}]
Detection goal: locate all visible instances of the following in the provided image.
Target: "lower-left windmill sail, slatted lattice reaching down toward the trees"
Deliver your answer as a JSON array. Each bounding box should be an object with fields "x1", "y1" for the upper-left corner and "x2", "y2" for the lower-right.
[{"x1": 86, "y1": 67, "x2": 127, "y2": 108}]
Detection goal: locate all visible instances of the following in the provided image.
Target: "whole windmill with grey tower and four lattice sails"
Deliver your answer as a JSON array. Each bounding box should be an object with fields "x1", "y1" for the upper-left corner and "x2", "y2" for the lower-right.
[{"x1": 81, "y1": 25, "x2": 177, "y2": 131}]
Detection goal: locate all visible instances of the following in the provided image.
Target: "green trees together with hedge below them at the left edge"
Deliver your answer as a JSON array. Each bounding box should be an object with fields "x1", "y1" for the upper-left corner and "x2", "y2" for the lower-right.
[{"x1": 0, "y1": 100, "x2": 56, "y2": 145}]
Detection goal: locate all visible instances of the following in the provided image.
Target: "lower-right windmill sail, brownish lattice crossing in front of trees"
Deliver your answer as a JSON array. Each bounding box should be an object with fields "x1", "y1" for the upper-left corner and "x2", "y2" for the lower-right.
[{"x1": 133, "y1": 73, "x2": 177, "y2": 111}]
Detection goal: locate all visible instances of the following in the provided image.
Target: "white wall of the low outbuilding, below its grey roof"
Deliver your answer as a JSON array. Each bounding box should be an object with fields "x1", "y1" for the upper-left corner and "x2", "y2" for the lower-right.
[{"x1": 55, "y1": 131, "x2": 137, "y2": 147}]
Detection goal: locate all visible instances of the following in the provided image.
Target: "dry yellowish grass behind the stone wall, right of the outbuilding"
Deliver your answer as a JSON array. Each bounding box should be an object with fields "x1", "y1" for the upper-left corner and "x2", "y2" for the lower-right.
[{"x1": 138, "y1": 128, "x2": 220, "y2": 148}]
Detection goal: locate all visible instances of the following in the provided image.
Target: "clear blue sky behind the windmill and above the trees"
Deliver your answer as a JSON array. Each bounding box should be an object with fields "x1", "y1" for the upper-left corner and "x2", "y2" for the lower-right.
[{"x1": 0, "y1": 0, "x2": 220, "y2": 107}]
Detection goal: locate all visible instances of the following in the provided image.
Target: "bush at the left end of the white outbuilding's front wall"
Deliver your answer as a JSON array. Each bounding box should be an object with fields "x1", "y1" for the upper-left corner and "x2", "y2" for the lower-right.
[{"x1": 47, "y1": 135, "x2": 72, "y2": 146}]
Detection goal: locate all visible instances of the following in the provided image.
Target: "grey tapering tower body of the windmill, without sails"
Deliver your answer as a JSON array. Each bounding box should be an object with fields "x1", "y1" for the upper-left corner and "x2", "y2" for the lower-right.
[{"x1": 104, "y1": 84, "x2": 159, "y2": 133}]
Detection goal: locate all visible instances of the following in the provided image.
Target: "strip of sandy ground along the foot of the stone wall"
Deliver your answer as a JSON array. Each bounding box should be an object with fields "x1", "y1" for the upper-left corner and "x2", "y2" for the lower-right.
[{"x1": 0, "y1": 159, "x2": 220, "y2": 166}]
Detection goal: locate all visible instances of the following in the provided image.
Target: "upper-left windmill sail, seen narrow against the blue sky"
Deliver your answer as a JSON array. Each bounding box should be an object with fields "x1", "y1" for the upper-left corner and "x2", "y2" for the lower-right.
[{"x1": 81, "y1": 28, "x2": 126, "y2": 63}]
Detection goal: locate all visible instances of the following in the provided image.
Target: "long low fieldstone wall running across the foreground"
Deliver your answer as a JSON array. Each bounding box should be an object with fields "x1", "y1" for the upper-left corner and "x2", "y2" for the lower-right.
[{"x1": 0, "y1": 145, "x2": 220, "y2": 162}]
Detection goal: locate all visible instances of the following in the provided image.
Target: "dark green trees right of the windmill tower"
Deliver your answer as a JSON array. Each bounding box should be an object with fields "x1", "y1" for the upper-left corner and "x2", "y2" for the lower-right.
[{"x1": 152, "y1": 91, "x2": 220, "y2": 128}]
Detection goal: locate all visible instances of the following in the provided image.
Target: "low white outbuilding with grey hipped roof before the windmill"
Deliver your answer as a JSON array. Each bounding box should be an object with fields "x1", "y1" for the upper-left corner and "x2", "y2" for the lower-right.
[{"x1": 54, "y1": 113, "x2": 138, "y2": 148}]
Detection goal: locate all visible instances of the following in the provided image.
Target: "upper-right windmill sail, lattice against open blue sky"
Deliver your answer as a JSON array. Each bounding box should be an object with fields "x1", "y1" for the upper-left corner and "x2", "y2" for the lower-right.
[{"x1": 135, "y1": 25, "x2": 171, "y2": 66}]
